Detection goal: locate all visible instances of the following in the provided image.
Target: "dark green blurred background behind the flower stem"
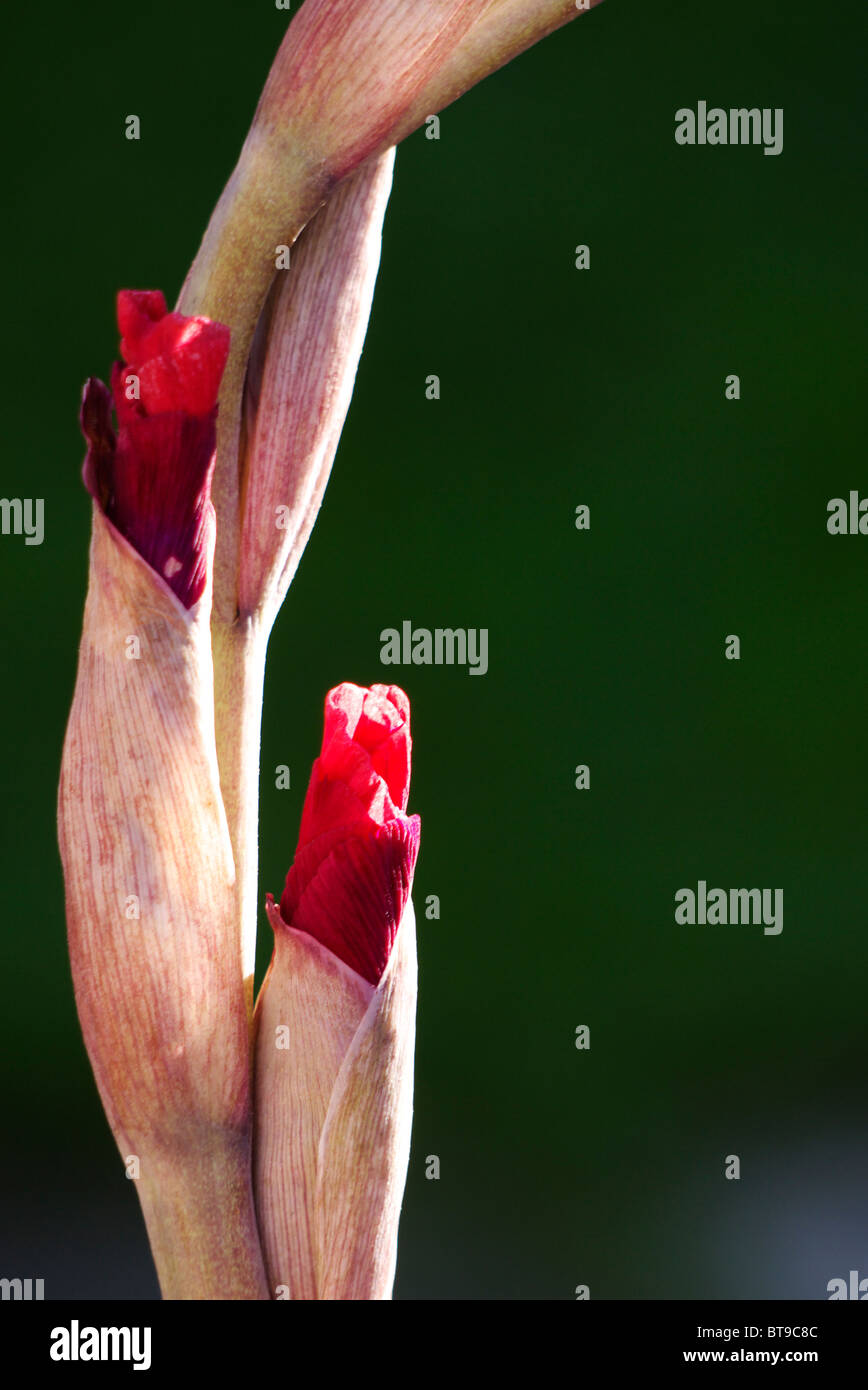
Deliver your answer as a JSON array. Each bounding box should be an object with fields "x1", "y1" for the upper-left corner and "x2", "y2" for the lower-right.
[{"x1": 0, "y1": 0, "x2": 868, "y2": 1300}]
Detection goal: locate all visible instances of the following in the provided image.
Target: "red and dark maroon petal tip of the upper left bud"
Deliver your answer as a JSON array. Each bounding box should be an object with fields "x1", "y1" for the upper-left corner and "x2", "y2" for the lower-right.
[{"x1": 81, "y1": 289, "x2": 230, "y2": 607}]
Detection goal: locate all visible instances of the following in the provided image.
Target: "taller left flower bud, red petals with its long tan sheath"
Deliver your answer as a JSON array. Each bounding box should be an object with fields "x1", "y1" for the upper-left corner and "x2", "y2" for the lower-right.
[{"x1": 58, "y1": 293, "x2": 267, "y2": 1298}]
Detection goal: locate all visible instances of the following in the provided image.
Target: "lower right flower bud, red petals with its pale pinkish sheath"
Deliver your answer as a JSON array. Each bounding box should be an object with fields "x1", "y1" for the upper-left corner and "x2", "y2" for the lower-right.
[{"x1": 253, "y1": 685, "x2": 419, "y2": 1300}]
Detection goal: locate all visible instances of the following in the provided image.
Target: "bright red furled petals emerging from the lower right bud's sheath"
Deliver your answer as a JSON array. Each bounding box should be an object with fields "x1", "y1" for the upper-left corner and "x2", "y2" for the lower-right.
[{"x1": 281, "y1": 684, "x2": 420, "y2": 984}]
